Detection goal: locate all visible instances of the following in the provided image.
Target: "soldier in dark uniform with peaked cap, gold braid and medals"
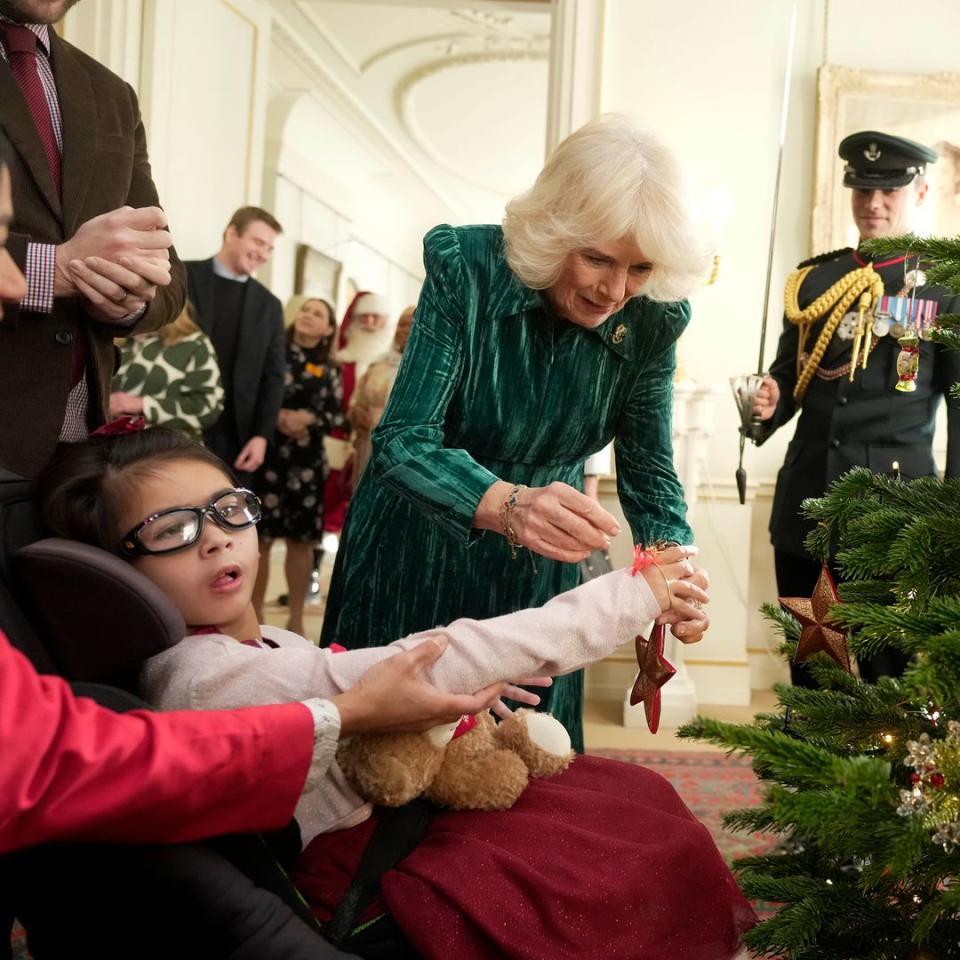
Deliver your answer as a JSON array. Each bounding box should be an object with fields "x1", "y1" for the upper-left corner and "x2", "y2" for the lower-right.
[{"x1": 754, "y1": 131, "x2": 960, "y2": 685}]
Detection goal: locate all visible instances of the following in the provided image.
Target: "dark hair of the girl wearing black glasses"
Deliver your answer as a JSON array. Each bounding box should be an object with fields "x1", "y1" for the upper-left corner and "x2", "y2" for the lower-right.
[{"x1": 37, "y1": 427, "x2": 236, "y2": 553}]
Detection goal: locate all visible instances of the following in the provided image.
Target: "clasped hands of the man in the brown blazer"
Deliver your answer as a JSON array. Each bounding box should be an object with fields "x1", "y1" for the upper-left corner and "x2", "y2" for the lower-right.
[{"x1": 54, "y1": 207, "x2": 173, "y2": 323}]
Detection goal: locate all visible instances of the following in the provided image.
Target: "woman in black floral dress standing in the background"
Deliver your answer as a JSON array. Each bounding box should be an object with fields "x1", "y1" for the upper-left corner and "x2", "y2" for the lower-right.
[{"x1": 254, "y1": 297, "x2": 346, "y2": 635}]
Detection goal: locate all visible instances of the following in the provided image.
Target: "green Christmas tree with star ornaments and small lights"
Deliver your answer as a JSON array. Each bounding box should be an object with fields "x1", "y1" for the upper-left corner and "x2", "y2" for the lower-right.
[{"x1": 680, "y1": 237, "x2": 960, "y2": 960}]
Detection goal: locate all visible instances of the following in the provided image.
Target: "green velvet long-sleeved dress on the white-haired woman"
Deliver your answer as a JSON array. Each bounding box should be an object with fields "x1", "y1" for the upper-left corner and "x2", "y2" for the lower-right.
[{"x1": 321, "y1": 225, "x2": 691, "y2": 750}]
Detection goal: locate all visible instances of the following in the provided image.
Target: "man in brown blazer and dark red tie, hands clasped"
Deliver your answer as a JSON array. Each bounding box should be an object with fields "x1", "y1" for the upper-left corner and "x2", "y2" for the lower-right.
[{"x1": 0, "y1": 0, "x2": 186, "y2": 477}]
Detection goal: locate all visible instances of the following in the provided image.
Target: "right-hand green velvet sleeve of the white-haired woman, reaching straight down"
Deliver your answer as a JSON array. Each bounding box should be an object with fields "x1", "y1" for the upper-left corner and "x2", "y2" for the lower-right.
[{"x1": 614, "y1": 303, "x2": 693, "y2": 544}]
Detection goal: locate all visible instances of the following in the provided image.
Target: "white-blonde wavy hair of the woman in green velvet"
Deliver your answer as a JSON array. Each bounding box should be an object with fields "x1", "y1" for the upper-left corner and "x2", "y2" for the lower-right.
[{"x1": 503, "y1": 113, "x2": 710, "y2": 300}]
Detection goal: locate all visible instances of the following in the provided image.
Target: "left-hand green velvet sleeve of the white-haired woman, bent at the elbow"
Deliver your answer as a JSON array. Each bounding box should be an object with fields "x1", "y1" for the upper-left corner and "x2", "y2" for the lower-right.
[{"x1": 372, "y1": 225, "x2": 498, "y2": 542}]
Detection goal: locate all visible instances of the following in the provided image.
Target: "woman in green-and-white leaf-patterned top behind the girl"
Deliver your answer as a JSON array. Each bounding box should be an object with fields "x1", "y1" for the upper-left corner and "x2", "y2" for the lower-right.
[{"x1": 110, "y1": 303, "x2": 223, "y2": 442}]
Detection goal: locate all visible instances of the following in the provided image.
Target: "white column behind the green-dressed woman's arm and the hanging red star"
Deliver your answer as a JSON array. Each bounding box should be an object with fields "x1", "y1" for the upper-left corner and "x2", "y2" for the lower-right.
[{"x1": 623, "y1": 381, "x2": 719, "y2": 728}]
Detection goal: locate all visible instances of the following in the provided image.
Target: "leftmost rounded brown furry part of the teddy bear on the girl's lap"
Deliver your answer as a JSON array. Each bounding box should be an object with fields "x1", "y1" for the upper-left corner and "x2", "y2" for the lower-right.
[{"x1": 337, "y1": 733, "x2": 445, "y2": 807}]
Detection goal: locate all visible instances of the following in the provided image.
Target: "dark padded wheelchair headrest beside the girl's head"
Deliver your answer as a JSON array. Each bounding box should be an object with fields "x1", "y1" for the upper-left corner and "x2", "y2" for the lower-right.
[{"x1": 16, "y1": 537, "x2": 187, "y2": 689}]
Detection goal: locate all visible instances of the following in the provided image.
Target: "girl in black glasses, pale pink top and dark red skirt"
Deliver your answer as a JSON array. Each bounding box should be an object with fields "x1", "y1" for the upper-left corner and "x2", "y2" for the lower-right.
[{"x1": 39, "y1": 428, "x2": 755, "y2": 960}]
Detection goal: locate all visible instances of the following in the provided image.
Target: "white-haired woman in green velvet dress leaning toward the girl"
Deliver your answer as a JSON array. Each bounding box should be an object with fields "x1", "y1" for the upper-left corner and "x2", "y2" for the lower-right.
[{"x1": 321, "y1": 115, "x2": 708, "y2": 750}]
